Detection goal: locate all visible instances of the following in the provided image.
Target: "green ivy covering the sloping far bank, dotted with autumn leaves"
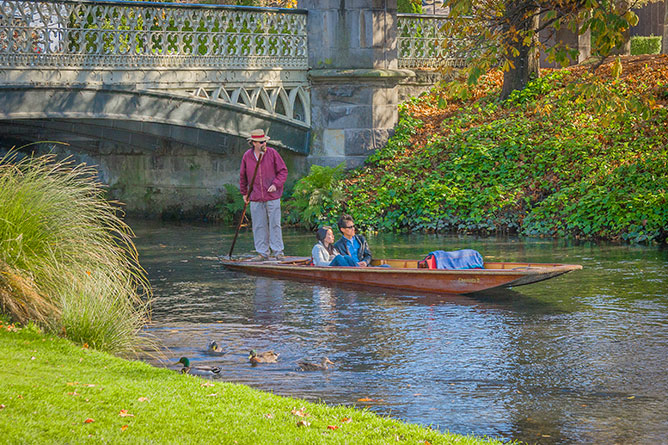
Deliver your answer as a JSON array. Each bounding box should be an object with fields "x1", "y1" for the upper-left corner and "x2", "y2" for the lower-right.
[{"x1": 292, "y1": 59, "x2": 668, "y2": 242}]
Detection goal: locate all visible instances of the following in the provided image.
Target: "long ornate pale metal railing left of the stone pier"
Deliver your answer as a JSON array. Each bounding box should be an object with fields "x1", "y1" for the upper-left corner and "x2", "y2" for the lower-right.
[{"x1": 0, "y1": 0, "x2": 308, "y2": 70}]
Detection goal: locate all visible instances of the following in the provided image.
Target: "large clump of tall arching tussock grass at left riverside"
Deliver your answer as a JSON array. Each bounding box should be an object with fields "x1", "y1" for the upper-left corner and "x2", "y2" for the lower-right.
[{"x1": 0, "y1": 153, "x2": 150, "y2": 355}]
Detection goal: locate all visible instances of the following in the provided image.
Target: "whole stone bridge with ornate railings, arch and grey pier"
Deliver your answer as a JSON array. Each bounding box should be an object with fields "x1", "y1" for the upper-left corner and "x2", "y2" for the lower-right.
[{"x1": 0, "y1": 0, "x2": 463, "y2": 215}]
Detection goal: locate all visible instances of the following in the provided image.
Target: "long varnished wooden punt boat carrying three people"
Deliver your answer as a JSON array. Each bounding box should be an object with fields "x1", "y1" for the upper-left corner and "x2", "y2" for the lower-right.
[{"x1": 221, "y1": 257, "x2": 582, "y2": 294}]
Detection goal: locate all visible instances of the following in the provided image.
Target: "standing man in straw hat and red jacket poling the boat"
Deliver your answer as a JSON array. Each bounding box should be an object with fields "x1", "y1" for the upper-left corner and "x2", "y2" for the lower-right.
[{"x1": 239, "y1": 130, "x2": 288, "y2": 261}]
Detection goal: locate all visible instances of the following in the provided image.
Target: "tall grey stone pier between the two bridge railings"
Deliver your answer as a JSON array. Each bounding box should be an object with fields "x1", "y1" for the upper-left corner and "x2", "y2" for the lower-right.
[{"x1": 298, "y1": 0, "x2": 413, "y2": 167}]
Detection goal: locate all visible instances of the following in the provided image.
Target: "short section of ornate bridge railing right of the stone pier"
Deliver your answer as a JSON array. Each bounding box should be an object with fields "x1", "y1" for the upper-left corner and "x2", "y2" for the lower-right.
[{"x1": 397, "y1": 14, "x2": 467, "y2": 69}]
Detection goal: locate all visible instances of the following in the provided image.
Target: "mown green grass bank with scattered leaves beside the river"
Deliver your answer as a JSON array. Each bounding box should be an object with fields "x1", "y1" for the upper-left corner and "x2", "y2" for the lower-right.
[{"x1": 0, "y1": 323, "x2": 501, "y2": 445}]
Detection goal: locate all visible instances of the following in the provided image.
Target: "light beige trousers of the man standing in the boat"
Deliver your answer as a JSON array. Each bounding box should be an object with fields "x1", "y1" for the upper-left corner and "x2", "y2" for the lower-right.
[{"x1": 251, "y1": 199, "x2": 283, "y2": 256}]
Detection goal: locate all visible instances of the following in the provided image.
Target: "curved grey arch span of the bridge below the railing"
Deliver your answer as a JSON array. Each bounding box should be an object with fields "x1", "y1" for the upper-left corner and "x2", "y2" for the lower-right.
[{"x1": 0, "y1": 85, "x2": 310, "y2": 155}]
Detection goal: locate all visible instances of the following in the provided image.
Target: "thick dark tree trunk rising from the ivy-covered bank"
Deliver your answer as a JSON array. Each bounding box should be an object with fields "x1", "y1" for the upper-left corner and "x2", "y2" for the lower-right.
[{"x1": 501, "y1": 0, "x2": 540, "y2": 100}]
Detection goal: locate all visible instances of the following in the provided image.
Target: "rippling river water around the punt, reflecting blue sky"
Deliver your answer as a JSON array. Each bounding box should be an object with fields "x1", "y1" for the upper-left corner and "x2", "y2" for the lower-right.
[{"x1": 130, "y1": 221, "x2": 668, "y2": 444}]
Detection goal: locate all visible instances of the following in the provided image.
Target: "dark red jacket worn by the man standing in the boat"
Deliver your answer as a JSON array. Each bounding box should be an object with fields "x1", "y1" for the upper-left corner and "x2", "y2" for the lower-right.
[{"x1": 239, "y1": 147, "x2": 288, "y2": 202}]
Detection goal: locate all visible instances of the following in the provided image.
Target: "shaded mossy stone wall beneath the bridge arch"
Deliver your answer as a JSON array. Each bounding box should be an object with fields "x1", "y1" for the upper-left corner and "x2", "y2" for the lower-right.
[{"x1": 2, "y1": 138, "x2": 307, "y2": 219}]
